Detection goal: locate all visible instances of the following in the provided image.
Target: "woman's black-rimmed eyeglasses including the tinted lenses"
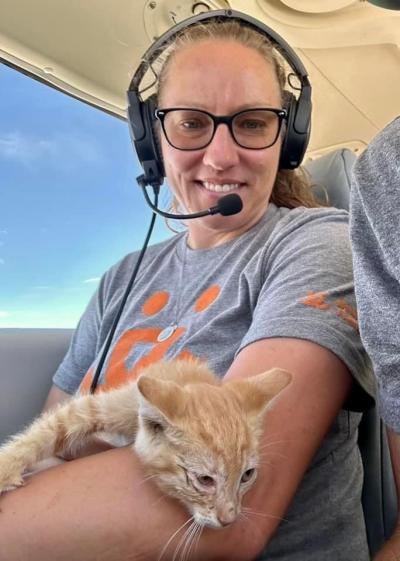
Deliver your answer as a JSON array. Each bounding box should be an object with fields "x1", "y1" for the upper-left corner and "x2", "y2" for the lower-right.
[{"x1": 155, "y1": 107, "x2": 287, "y2": 150}]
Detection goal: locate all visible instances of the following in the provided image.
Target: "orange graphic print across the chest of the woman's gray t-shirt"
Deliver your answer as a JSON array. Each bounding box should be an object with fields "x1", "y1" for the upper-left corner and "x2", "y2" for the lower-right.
[{"x1": 79, "y1": 285, "x2": 220, "y2": 393}]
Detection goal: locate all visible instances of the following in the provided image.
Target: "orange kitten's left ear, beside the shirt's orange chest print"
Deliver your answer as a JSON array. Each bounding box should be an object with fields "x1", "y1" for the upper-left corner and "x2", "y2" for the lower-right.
[{"x1": 137, "y1": 374, "x2": 186, "y2": 424}]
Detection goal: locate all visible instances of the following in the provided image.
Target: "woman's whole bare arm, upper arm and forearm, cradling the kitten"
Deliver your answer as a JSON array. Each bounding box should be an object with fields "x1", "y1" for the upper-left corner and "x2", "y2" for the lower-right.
[{"x1": 0, "y1": 339, "x2": 351, "y2": 561}]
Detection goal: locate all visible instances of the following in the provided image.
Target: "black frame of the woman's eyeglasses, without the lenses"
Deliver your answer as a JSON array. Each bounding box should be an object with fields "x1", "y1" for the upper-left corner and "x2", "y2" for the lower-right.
[{"x1": 154, "y1": 107, "x2": 288, "y2": 152}]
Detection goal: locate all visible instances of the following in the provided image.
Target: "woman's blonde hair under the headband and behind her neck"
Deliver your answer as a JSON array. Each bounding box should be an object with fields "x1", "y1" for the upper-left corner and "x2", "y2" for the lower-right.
[{"x1": 156, "y1": 20, "x2": 320, "y2": 208}]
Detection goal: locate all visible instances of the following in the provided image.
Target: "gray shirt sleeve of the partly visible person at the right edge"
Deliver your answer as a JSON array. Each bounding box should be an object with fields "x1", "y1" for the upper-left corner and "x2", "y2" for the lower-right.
[{"x1": 351, "y1": 117, "x2": 400, "y2": 433}]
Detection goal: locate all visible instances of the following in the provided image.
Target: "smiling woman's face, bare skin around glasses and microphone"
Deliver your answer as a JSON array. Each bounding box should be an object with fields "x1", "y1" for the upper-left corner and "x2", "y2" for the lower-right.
[{"x1": 159, "y1": 40, "x2": 281, "y2": 248}]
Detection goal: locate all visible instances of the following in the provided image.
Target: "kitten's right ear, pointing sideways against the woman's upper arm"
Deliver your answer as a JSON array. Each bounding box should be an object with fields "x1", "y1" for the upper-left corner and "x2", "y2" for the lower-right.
[{"x1": 225, "y1": 368, "x2": 293, "y2": 415}]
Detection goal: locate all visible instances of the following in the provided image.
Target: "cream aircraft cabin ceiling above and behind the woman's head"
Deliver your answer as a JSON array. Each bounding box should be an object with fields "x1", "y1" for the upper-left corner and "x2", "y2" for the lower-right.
[{"x1": 0, "y1": 0, "x2": 400, "y2": 155}]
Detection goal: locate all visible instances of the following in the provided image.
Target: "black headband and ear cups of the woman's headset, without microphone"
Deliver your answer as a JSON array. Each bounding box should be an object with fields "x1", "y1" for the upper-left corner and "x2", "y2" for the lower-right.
[{"x1": 127, "y1": 10, "x2": 311, "y2": 187}]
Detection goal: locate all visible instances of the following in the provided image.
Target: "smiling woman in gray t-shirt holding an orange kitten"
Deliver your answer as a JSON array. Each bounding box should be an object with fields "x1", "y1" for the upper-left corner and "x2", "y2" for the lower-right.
[{"x1": 0, "y1": 9, "x2": 372, "y2": 561}]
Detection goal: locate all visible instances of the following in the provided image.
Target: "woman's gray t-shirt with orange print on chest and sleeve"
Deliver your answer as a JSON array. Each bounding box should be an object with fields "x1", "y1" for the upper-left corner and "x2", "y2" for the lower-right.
[{"x1": 54, "y1": 204, "x2": 374, "y2": 561}]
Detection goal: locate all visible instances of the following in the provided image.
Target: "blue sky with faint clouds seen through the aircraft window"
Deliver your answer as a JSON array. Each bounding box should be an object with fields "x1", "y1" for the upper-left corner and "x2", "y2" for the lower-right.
[{"x1": 0, "y1": 64, "x2": 171, "y2": 327}]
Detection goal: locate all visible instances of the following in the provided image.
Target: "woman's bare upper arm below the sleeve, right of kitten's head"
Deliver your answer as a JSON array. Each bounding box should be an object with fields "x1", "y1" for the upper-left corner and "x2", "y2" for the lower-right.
[{"x1": 226, "y1": 338, "x2": 352, "y2": 543}]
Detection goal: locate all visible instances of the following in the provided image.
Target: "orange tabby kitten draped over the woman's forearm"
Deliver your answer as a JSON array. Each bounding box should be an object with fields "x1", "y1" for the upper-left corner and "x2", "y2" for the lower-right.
[{"x1": 0, "y1": 360, "x2": 291, "y2": 528}]
